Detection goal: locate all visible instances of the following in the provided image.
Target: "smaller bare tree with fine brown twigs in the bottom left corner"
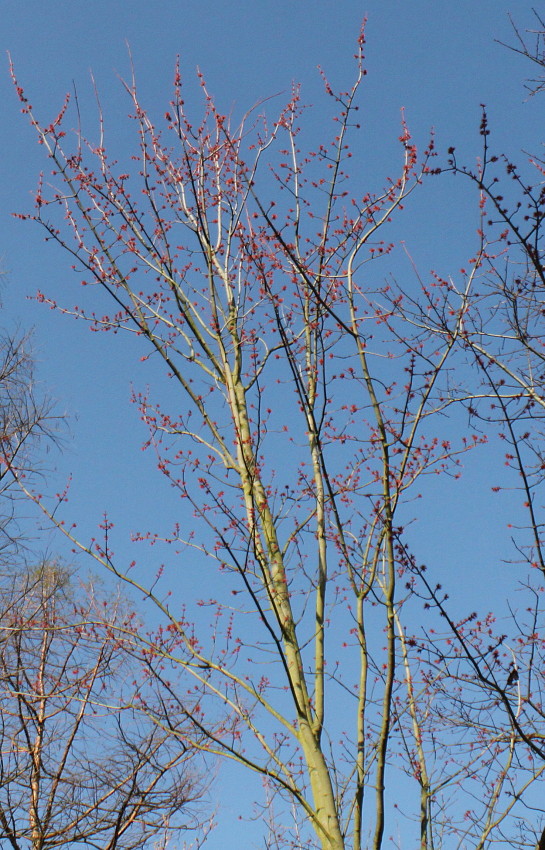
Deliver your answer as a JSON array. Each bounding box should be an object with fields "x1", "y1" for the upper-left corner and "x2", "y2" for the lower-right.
[{"x1": 0, "y1": 563, "x2": 206, "y2": 850}]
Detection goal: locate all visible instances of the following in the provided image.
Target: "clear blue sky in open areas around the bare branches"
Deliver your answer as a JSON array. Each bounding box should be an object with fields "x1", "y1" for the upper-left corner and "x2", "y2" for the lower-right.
[{"x1": 0, "y1": 0, "x2": 543, "y2": 847}]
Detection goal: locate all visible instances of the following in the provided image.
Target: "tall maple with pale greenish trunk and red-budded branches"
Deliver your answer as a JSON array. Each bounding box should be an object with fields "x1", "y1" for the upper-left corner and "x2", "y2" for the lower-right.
[{"x1": 9, "y1": 18, "x2": 545, "y2": 850}]
